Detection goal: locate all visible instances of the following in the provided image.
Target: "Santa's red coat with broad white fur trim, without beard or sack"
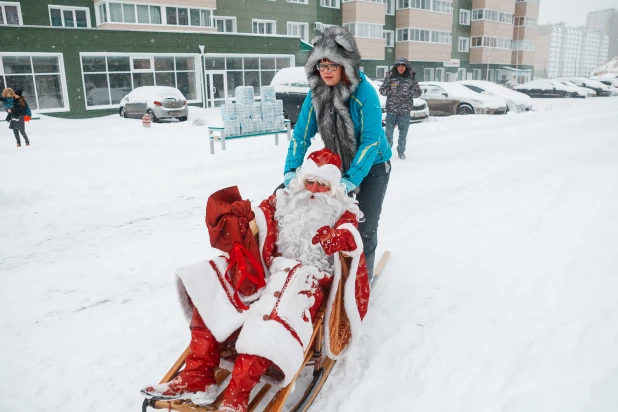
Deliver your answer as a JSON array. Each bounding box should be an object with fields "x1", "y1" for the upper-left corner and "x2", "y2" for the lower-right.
[{"x1": 176, "y1": 195, "x2": 369, "y2": 387}]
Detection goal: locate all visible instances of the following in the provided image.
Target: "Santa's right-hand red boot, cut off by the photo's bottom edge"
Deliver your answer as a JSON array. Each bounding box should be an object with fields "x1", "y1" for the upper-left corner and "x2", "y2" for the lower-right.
[{"x1": 219, "y1": 354, "x2": 272, "y2": 412}]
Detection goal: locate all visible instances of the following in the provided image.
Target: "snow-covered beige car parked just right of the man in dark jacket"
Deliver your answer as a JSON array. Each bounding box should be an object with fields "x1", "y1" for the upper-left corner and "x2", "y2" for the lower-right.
[{"x1": 419, "y1": 82, "x2": 507, "y2": 116}]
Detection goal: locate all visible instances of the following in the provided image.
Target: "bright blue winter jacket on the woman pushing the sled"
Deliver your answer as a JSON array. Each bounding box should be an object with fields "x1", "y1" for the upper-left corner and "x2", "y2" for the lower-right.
[{"x1": 283, "y1": 73, "x2": 392, "y2": 186}]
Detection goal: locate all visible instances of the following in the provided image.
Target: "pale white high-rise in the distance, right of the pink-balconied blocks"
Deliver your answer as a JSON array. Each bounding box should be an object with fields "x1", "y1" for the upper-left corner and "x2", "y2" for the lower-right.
[{"x1": 534, "y1": 23, "x2": 610, "y2": 78}]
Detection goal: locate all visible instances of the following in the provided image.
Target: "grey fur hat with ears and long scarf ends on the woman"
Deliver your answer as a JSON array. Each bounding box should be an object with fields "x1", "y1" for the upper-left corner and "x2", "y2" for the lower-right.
[{"x1": 305, "y1": 26, "x2": 361, "y2": 173}]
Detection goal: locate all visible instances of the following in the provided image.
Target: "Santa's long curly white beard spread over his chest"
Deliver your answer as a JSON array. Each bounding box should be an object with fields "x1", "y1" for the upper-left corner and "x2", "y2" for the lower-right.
[{"x1": 275, "y1": 188, "x2": 362, "y2": 271}]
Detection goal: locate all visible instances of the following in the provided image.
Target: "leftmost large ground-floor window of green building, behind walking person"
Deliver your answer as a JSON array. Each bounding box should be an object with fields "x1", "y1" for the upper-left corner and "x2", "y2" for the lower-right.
[{"x1": 0, "y1": 53, "x2": 69, "y2": 113}]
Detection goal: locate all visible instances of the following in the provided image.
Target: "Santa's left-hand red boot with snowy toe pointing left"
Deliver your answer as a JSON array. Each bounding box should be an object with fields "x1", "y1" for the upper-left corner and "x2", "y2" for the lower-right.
[{"x1": 141, "y1": 308, "x2": 220, "y2": 405}]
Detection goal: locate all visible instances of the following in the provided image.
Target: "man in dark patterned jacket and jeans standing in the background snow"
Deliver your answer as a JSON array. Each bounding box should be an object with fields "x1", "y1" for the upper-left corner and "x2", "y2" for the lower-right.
[{"x1": 380, "y1": 58, "x2": 422, "y2": 160}]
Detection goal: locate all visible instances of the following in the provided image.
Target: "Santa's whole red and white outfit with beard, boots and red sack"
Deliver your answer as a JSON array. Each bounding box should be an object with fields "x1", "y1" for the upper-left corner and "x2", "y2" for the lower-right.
[{"x1": 142, "y1": 149, "x2": 369, "y2": 412}]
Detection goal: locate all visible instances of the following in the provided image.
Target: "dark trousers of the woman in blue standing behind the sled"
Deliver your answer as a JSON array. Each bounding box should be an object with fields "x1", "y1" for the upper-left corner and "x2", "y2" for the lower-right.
[{"x1": 356, "y1": 161, "x2": 391, "y2": 280}]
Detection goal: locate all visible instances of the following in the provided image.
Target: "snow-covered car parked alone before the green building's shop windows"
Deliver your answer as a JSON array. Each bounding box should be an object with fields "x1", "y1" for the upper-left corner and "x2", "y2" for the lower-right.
[{"x1": 118, "y1": 86, "x2": 189, "y2": 122}]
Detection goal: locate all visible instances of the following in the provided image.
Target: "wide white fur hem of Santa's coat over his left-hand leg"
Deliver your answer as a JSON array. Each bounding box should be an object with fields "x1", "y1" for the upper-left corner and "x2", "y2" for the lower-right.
[{"x1": 176, "y1": 256, "x2": 247, "y2": 342}]
